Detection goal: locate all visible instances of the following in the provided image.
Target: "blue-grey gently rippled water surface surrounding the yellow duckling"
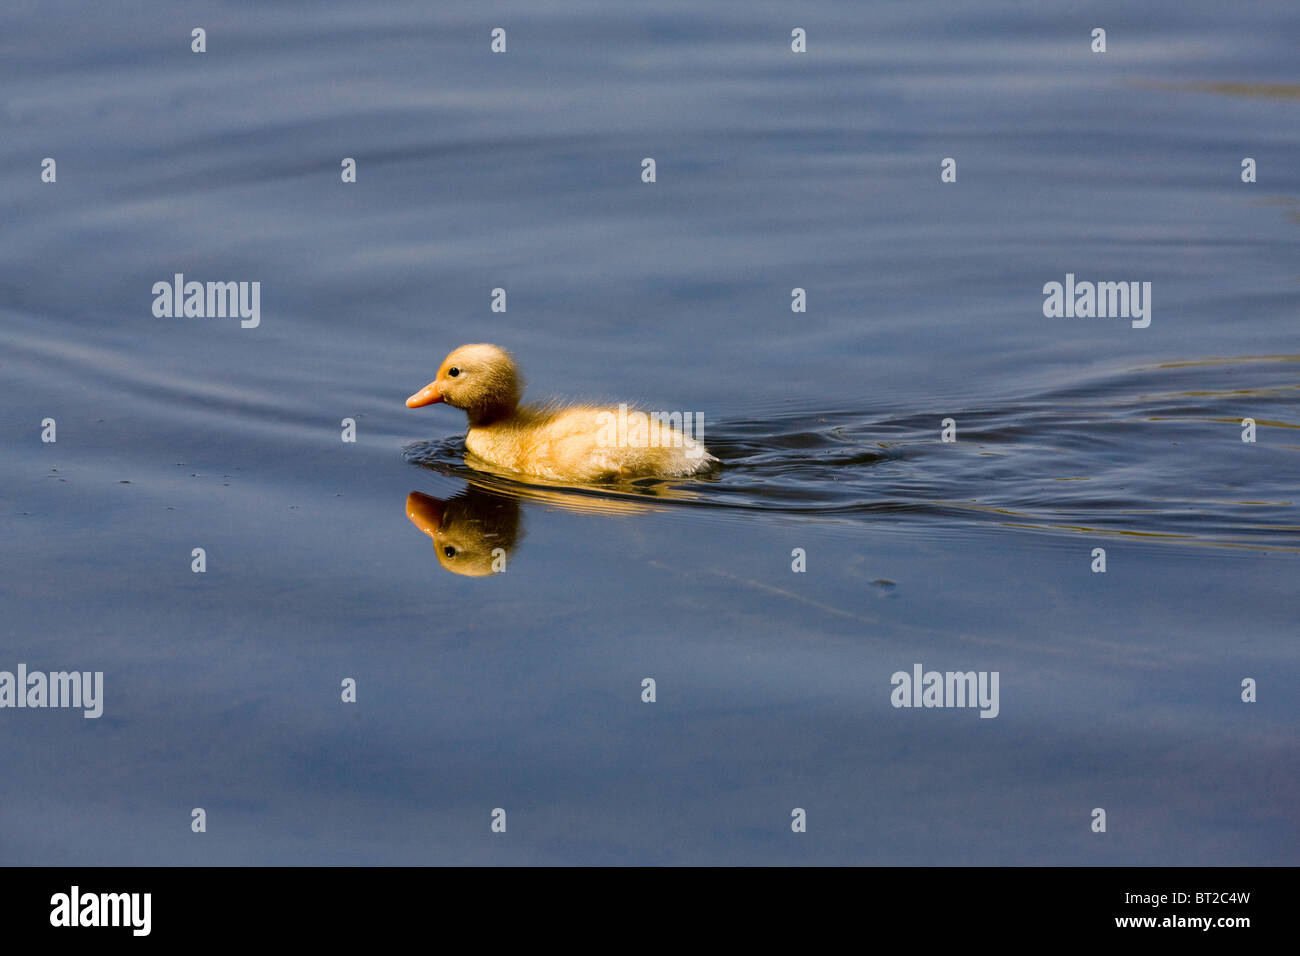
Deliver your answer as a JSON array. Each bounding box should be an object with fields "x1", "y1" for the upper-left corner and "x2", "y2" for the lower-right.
[{"x1": 0, "y1": 0, "x2": 1300, "y2": 865}]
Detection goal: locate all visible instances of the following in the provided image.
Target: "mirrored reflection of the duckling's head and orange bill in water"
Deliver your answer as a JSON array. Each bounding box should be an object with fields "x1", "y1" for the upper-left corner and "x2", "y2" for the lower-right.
[{"x1": 407, "y1": 485, "x2": 524, "y2": 578}]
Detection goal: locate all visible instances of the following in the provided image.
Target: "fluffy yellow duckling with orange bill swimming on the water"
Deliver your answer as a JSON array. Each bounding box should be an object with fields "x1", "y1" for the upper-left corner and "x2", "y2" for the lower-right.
[{"x1": 407, "y1": 345, "x2": 718, "y2": 483}]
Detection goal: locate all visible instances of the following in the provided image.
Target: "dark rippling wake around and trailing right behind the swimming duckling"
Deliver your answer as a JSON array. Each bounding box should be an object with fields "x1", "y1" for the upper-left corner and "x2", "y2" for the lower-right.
[{"x1": 406, "y1": 355, "x2": 1300, "y2": 550}]
